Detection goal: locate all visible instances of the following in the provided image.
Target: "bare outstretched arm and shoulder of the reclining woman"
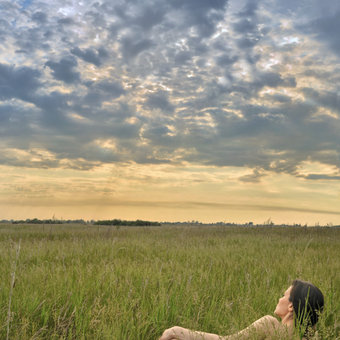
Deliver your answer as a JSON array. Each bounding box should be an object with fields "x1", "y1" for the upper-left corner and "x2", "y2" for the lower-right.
[{"x1": 159, "y1": 315, "x2": 284, "y2": 340}]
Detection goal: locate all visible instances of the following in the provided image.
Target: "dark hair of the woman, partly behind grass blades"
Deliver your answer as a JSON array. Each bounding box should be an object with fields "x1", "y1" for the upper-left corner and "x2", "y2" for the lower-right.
[{"x1": 289, "y1": 280, "x2": 324, "y2": 329}]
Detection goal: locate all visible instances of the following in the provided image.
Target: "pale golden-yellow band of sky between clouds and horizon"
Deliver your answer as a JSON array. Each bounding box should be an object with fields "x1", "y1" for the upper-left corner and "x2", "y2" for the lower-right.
[{"x1": 0, "y1": 163, "x2": 340, "y2": 225}]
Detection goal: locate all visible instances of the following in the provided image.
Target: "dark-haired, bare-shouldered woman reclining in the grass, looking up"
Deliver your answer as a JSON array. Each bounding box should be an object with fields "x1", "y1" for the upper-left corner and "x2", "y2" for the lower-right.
[{"x1": 159, "y1": 280, "x2": 324, "y2": 340}]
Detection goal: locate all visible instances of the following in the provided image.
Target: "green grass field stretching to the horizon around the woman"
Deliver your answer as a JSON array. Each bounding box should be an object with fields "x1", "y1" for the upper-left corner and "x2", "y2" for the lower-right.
[{"x1": 0, "y1": 224, "x2": 340, "y2": 340}]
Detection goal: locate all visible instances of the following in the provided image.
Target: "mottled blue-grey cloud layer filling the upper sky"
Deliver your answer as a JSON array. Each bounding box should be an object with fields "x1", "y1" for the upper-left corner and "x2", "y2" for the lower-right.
[{"x1": 0, "y1": 0, "x2": 340, "y2": 183}]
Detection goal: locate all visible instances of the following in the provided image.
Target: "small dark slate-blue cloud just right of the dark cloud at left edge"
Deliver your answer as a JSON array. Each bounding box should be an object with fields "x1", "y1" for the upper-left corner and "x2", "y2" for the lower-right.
[{"x1": 45, "y1": 56, "x2": 80, "y2": 84}]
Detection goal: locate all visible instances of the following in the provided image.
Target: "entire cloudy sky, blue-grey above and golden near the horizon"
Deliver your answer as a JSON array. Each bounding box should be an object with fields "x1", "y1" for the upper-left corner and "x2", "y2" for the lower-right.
[{"x1": 0, "y1": 0, "x2": 340, "y2": 225}]
